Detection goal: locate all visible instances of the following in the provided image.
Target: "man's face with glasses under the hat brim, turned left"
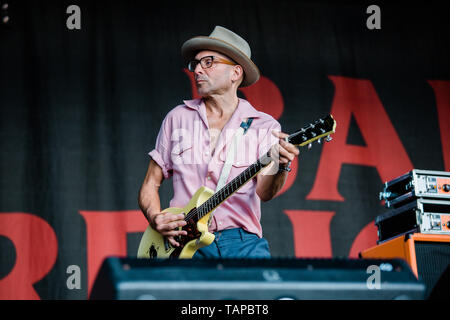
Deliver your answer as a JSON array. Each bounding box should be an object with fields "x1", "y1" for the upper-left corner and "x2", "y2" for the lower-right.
[{"x1": 194, "y1": 50, "x2": 239, "y2": 97}]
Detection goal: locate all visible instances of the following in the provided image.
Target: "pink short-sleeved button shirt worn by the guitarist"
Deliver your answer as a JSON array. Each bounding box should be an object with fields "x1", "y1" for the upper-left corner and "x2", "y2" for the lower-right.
[{"x1": 149, "y1": 99, "x2": 281, "y2": 237}]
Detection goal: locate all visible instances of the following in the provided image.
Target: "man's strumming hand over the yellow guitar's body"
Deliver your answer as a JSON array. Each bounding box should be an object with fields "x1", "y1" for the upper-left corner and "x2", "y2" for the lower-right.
[{"x1": 149, "y1": 212, "x2": 187, "y2": 247}]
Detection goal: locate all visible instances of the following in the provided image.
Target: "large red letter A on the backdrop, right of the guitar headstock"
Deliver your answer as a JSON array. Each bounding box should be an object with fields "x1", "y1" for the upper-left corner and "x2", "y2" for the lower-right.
[{"x1": 306, "y1": 76, "x2": 413, "y2": 201}]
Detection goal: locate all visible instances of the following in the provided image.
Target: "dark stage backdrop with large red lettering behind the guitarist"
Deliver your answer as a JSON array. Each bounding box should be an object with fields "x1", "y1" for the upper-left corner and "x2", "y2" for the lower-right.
[{"x1": 0, "y1": 0, "x2": 450, "y2": 299}]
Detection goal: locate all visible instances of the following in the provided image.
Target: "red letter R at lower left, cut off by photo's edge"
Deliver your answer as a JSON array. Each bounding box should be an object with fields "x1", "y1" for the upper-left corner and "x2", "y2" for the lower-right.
[{"x1": 0, "y1": 212, "x2": 58, "y2": 300}]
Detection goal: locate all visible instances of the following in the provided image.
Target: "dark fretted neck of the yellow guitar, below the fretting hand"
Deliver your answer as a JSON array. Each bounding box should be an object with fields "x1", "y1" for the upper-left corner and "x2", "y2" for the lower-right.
[{"x1": 197, "y1": 156, "x2": 270, "y2": 219}]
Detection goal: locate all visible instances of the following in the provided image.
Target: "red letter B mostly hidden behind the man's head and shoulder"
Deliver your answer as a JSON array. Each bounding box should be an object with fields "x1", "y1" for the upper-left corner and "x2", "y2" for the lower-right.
[{"x1": 183, "y1": 69, "x2": 298, "y2": 196}]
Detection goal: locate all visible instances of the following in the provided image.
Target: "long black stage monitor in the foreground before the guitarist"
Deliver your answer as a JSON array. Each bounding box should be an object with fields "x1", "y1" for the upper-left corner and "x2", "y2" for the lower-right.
[{"x1": 90, "y1": 257, "x2": 425, "y2": 300}]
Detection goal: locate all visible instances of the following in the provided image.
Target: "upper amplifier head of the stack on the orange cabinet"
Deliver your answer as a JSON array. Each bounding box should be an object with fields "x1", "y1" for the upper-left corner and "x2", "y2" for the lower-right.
[{"x1": 380, "y1": 169, "x2": 450, "y2": 208}]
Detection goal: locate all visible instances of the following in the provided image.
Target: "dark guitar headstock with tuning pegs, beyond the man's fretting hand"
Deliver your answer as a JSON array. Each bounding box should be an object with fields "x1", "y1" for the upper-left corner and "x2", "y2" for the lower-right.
[{"x1": 287, "y1": 114, "x2": 336, "y2": 147}]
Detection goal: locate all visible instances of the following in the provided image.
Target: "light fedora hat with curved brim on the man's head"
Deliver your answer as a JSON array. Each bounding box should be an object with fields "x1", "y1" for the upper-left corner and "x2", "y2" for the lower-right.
[{"x1": 181, "y1": 26, "x2": 259, "y2": 87}]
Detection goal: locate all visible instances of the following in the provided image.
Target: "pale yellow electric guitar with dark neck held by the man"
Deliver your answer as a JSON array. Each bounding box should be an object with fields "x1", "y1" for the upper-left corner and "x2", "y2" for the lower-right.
[{"x1": 137, "y1": 115, "x2": 336, "y2": 259}]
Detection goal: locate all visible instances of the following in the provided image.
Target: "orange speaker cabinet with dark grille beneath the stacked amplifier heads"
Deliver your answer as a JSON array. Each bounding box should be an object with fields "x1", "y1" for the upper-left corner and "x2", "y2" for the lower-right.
[{"x1": 360, "y1": 233, "x2": 450, "y2": 298}]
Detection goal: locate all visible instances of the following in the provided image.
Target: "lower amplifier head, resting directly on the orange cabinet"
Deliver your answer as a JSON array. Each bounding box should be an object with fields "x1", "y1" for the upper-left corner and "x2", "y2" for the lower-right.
[{"x1": 375, "y1": 198, "x2": 450, "y2": 244}]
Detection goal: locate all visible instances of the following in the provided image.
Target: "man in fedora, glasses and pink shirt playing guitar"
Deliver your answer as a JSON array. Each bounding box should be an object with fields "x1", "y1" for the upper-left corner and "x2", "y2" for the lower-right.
[{"x1": 139, "y1": 26, "x2": 299, "y2": 258}]
